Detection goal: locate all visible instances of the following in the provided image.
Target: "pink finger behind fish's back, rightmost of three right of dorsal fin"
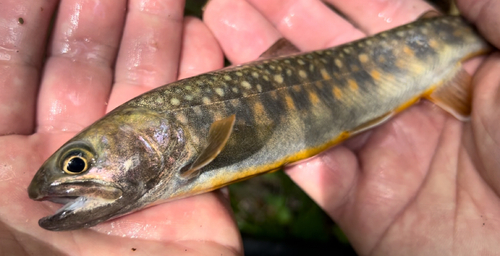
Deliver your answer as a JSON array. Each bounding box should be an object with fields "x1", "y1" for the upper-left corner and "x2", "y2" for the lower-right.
[{"x1": 326, "y1": 0, "x2": 433, "y2": 35}]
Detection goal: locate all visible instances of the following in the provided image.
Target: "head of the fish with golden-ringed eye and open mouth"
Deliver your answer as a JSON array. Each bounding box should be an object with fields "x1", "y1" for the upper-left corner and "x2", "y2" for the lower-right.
[{"x1": 28, "y1": 109, "x2": 188, "y2": 230}]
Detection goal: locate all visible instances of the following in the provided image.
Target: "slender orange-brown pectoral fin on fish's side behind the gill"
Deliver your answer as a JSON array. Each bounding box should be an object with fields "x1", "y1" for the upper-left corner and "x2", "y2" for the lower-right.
[{"x1": 181, "y1": 115, "x2": 236, "y2": 179}]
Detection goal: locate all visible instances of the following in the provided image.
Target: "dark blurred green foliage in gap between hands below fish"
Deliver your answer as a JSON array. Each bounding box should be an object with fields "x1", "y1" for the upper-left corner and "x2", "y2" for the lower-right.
[{"x1": 229, "y1": 171, "x2": 345, "y2": 241}]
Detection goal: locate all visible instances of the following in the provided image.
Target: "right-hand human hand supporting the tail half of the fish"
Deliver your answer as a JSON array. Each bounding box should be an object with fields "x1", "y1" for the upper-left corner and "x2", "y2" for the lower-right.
[{"x1": 204, "y1": 0, "x2": 500, "y2": 255}]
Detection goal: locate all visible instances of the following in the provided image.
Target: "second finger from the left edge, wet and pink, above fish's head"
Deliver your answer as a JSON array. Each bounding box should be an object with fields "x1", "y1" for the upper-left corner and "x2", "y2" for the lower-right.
[{"x1": 37, "y1": 0, "x2": 126, "y2": 131}]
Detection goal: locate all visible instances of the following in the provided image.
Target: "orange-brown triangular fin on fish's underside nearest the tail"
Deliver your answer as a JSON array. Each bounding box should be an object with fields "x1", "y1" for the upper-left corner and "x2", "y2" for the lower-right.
[{"x1": 425, "y1": 67, "x2": 472, "y2": 121}]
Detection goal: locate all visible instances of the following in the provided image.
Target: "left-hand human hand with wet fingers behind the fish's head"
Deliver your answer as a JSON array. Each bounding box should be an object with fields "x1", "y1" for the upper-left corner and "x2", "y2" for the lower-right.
[{"x1": 0, "y1": 0, "x2": 242, "y2": 255}]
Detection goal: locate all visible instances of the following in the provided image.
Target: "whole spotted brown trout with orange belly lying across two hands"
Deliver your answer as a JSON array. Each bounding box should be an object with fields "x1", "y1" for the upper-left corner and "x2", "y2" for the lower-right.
[{"x1": 28, "y1": 14, "x2": 492, "y2": 231}]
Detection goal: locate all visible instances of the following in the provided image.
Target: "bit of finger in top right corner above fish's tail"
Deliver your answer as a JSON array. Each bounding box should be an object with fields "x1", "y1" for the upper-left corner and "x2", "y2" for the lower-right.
[{"x1": 457, "y1": 0, "x2": 500, "y2": 48}]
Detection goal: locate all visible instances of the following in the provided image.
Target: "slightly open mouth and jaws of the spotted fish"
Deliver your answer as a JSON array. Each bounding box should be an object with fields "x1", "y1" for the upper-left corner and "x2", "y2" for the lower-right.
[{"x1": 29, "y1": 181, "x2": 123, "y2": 231}]
